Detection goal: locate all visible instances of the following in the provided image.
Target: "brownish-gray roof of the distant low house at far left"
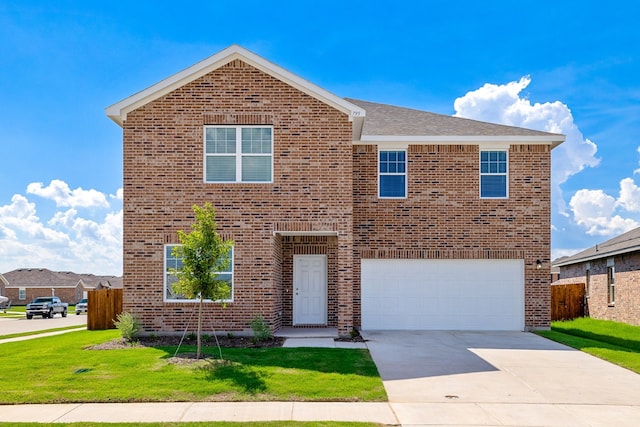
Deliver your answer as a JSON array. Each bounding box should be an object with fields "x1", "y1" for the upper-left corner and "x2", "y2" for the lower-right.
[{"x1": 2, "y1": 268, "x2": 122, "y2": 288}]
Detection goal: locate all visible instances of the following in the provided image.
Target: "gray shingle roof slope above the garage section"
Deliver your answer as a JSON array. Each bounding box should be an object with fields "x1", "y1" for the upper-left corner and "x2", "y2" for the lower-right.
[{"x1": 345, "y1": 98, "x2": 564, "y2": 141}]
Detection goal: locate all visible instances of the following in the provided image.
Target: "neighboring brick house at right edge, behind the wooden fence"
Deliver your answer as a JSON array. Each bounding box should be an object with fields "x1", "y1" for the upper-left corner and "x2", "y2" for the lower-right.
[{"x1": 553, "y1": 228, "x2": 640, "y2": 325}]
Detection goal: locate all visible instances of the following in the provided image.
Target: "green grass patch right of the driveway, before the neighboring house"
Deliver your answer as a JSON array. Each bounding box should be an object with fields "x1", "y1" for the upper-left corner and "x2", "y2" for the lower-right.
[{"x1": 537, "y1": 318, "x2": 640, "y2": 374}]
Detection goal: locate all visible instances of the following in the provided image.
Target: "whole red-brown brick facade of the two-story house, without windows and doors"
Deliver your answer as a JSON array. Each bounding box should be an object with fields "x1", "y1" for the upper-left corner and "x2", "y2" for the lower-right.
[{"x1": 123, "y1": 53, "x2": 551, "y2": 335}]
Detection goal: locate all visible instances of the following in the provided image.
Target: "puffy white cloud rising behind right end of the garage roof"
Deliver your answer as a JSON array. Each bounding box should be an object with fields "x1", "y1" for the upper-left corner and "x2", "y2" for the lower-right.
[{"x1": 453, "y1": 76, "x2": 600, "y2": 216}]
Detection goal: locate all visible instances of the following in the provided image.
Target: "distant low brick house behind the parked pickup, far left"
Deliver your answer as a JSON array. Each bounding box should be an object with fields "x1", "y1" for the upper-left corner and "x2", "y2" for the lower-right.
[{"x1": 0, "y1": 268, "x2": 122, "y2": 305}]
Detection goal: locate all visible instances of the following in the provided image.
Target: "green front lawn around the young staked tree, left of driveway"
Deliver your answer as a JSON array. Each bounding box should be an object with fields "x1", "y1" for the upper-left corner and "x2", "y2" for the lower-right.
[{"x1": 0, "y1": 330, "x2": 386, "y2": 404}]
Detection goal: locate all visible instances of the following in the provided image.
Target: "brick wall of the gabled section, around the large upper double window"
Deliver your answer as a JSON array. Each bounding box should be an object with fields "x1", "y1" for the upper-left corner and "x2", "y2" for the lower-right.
[{"x1": 123, "y1": 60, "x2": 353, "y2": 333}]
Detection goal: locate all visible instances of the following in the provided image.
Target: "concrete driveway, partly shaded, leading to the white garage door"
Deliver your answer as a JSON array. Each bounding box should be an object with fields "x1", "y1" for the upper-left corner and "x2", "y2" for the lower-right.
[{"x1": 362, "y1": 331, "x2": 640, "y2": 427}]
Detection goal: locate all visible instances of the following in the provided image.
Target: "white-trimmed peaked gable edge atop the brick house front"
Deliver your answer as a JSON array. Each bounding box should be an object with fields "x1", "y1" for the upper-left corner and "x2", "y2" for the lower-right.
[{"x1": 106, "y1": 45, "x2": 365, "y2": 126}]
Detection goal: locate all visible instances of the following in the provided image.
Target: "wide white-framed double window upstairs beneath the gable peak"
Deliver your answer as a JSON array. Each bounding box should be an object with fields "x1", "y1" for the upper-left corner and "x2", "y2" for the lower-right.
[{"x1": 204, "y1": 126, "x2": 273, "y2": 182}]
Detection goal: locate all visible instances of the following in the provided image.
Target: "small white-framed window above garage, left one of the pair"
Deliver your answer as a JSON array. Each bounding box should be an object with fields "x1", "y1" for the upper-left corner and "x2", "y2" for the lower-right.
[{"x1": 378, "y1": 150, "x2": 407, "y2": 198}]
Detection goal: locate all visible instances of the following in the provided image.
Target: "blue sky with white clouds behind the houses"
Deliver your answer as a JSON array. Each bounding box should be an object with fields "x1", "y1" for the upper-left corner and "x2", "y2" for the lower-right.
[{"x1": 0, "y1": 0, "x2": 640, "y2": 275}]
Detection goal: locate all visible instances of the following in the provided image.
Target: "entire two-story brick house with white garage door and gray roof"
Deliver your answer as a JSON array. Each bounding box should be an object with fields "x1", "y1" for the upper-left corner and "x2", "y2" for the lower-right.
[{"x1": 106, "y1": 46, "x2": 564, "y2": 336}]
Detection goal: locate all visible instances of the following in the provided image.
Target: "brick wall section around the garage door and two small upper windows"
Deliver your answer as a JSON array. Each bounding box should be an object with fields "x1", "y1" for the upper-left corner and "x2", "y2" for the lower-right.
[{"x1": 353, "y1": 145, "x2": 551, "y2": 329}]
